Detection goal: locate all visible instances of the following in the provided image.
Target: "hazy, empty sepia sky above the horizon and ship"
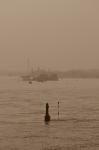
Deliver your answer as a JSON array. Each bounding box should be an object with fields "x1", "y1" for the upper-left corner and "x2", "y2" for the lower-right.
[{"x1": 0, "y1": 0, "x2": 99, "y2": 70}]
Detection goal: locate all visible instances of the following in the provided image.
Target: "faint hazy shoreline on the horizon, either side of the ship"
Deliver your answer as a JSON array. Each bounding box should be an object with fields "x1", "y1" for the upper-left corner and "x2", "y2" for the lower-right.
[{"x1": 0, "y1": 69, "x2": 99, "y2": 79}]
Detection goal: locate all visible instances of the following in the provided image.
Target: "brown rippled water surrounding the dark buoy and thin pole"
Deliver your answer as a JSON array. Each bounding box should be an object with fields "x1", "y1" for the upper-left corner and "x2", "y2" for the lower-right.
[{"x1": 0, "y1": 77, "x2": 99, "y2": 150}]
